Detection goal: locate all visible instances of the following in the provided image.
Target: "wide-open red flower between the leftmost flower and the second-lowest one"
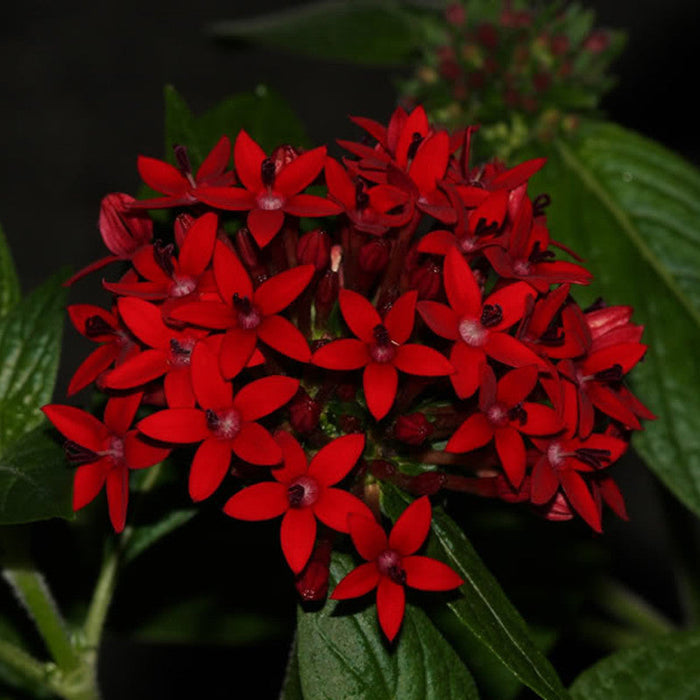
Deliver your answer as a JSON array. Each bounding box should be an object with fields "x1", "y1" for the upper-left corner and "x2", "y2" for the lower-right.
[{"x1": 137, "y1": 343, "x2": 299, "y2": 501}]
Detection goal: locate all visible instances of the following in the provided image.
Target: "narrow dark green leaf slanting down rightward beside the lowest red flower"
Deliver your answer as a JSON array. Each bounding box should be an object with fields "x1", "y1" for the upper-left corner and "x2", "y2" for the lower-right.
[{"x1": 382, "y1": 485, "x2": 568, "y2": 698}]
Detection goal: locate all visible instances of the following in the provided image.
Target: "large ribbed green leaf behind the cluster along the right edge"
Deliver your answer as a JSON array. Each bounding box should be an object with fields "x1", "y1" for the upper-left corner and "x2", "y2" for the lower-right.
[{"x1": 532, "y1": 122, "x2": 700, "y2": 515}]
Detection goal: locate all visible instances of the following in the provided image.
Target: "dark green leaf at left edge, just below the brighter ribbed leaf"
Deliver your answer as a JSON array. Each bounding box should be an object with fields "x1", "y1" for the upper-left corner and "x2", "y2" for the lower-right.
[{"x1": 0, "y1": 427, "x2": 73, "y2": 525}]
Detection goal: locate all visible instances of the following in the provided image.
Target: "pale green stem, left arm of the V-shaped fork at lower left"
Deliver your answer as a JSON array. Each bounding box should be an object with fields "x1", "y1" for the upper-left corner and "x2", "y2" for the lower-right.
[{"x1": 4, "y1": 568, "x2": 80, "y2": 671}]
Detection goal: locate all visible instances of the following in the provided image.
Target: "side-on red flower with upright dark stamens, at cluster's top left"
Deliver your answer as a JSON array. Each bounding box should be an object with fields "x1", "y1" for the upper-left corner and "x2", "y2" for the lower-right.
[{"x1": 132, "y1": 136, "x2": 235, "y2": 209}]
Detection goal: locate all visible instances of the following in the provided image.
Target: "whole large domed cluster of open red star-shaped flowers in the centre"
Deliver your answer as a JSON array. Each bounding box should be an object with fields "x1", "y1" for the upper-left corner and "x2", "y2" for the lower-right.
[{"x1": 44, "y1": 102, "x2": 653, "y2": 639}]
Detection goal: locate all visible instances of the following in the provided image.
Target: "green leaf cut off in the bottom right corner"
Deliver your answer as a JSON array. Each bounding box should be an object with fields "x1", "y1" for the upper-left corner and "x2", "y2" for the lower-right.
[{"x1": 571, "y1": 630, "x2": 700, "y2": 700}]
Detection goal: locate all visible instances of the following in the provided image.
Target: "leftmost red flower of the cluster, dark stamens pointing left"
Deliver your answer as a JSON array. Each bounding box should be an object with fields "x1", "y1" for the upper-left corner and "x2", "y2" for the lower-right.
[{"x1": 41, "y1": 393, "x2": 170, "y2": 532}]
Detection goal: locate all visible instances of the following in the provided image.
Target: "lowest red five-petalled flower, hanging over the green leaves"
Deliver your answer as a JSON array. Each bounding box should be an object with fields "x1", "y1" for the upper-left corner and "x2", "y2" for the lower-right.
[{"x1": 331, "y1": 496, "x2": 464, "y2": 641}]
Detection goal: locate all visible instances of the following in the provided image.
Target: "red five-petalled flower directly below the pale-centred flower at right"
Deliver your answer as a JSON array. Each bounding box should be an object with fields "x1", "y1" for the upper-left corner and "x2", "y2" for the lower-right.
[{"x1": 445, "y1": 365, "x2": 562, "y2": 488}]
